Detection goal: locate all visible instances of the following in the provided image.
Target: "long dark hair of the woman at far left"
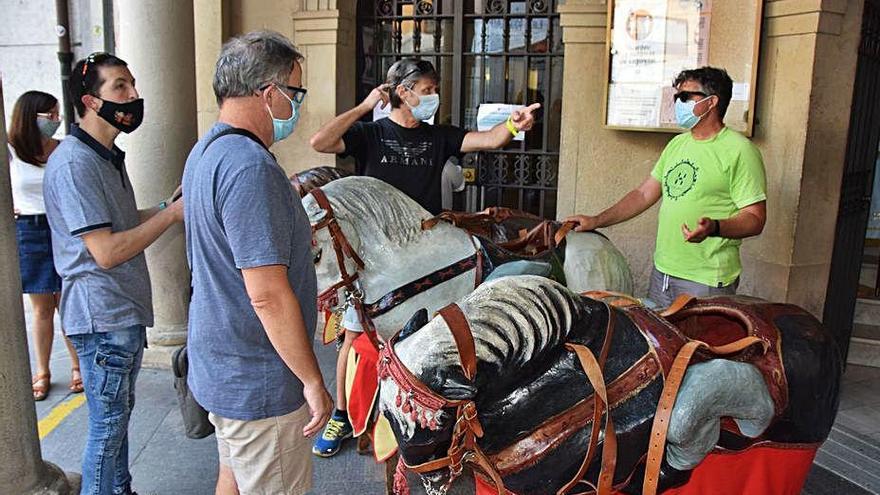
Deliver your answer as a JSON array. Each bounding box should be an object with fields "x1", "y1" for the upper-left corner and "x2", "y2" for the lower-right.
[{"x1": 9, "y1": 91, "x2": 58, "y2": 167}]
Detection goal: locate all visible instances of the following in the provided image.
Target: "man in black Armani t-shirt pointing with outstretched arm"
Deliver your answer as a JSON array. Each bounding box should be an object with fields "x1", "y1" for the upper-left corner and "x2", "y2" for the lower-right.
[{"x1": 311, "y1": 58, "x2": 540, "y2": 214}]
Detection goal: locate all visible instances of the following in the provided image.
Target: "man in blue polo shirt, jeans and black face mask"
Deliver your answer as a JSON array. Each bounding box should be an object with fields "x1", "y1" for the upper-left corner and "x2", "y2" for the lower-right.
[{"x1": 43, "y1": 53, "x2": 183, "y2": 495}]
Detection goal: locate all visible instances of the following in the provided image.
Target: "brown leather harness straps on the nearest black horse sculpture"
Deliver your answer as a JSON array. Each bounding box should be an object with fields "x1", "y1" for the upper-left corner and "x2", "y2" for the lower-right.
[{"x1": 378, "y1": 292, "x2": 768, "y2": 495}]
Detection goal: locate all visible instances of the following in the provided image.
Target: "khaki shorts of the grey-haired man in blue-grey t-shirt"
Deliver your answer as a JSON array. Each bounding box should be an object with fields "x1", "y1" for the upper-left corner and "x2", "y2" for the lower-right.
[{"x1": 208, "y1": 405, "x2": 312, "y2": 495}]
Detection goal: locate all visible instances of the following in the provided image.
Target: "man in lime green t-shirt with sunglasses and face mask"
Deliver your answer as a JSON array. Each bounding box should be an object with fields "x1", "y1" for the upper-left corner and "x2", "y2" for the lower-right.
[{"x1": 565, "y1": 67, "x2": 767, "y2": 307}]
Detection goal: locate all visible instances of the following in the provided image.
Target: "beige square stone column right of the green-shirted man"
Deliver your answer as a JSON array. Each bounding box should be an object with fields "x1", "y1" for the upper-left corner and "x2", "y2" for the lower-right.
[{"x1": 741, "y1": 0, "x2": 864, "y2": 318}]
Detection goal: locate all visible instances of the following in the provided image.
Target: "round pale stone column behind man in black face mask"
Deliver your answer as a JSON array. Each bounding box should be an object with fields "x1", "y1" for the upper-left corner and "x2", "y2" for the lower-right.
[{"x1": 116, "y1": 0, "x2": 197, "y2": 366}]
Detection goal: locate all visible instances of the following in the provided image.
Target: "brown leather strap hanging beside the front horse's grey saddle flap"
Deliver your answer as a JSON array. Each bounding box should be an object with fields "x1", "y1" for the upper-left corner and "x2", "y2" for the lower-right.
[{"x1": 642, "y1": 337, "x2": 765, "y2": 495}]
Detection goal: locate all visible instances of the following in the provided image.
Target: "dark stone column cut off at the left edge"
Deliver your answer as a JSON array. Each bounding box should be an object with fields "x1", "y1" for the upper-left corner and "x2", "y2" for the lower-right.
[{"x1": 0, "y1": 81, "x2": 79, "y2": 495}]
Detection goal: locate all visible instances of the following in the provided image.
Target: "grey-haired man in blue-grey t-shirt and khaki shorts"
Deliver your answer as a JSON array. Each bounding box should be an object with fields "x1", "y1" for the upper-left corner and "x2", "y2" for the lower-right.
[{"x1": 183, "y1": 32, "x2": 332, "y2": 494}]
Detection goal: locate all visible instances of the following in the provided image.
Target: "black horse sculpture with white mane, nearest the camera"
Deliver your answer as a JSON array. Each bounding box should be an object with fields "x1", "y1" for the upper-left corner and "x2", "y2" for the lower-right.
[{"x1": 379, "y1": 276, "x2": 841, "y2": 495}]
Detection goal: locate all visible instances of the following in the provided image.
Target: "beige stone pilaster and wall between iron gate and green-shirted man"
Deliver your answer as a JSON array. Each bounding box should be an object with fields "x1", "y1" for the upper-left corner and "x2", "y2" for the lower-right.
[{"x1": 557, "y1": 0, "x2": 672, "y2": 295}]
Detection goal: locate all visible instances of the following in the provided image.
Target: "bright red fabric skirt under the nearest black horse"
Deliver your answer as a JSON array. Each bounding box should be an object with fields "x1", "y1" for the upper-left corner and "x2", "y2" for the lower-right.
[{"x1": 475, "y1": 446, "x2": 817, "y2": 495}]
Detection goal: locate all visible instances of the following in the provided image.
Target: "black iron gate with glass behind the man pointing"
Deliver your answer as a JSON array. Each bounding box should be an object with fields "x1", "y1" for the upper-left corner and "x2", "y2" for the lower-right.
[{"x1": 356, "y1": 0, "x2": 563, "y2": 218}]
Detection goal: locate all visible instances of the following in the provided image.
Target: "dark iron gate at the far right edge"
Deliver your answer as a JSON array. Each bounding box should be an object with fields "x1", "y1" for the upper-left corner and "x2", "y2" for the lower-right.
[{"x1": 823, "y1": 0, "x2": 880, "y2": 360}]
